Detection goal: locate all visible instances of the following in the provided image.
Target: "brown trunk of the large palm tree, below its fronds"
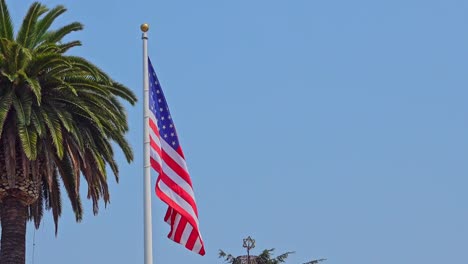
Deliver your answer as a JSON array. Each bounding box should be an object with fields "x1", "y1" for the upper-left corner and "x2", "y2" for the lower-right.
[{"x1": 0, "y1": 197, "x2": 27, "y2": 264}]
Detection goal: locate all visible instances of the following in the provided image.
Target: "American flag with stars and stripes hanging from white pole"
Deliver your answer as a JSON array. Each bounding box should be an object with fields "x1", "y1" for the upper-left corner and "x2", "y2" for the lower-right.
[{"x1": 148, "y1": 58, "x2": 205, "y2": 255}]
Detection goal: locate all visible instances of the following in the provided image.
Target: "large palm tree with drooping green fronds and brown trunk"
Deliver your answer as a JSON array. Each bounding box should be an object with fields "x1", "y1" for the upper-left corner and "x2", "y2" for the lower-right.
[{"x1": 0, "y1": 0, "x2": 136, "y2": 264}]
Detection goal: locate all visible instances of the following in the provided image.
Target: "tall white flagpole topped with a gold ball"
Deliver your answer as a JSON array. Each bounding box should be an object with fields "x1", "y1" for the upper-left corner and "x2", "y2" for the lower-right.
[{"x1": 140, "y1": 24, "x2": 153, "y2": 264}]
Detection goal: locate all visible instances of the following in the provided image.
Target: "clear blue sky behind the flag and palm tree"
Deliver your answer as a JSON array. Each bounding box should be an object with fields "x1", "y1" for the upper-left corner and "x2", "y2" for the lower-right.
[{"x1": 7, "y1": 0, "x2": 468, "y2": 264}]
